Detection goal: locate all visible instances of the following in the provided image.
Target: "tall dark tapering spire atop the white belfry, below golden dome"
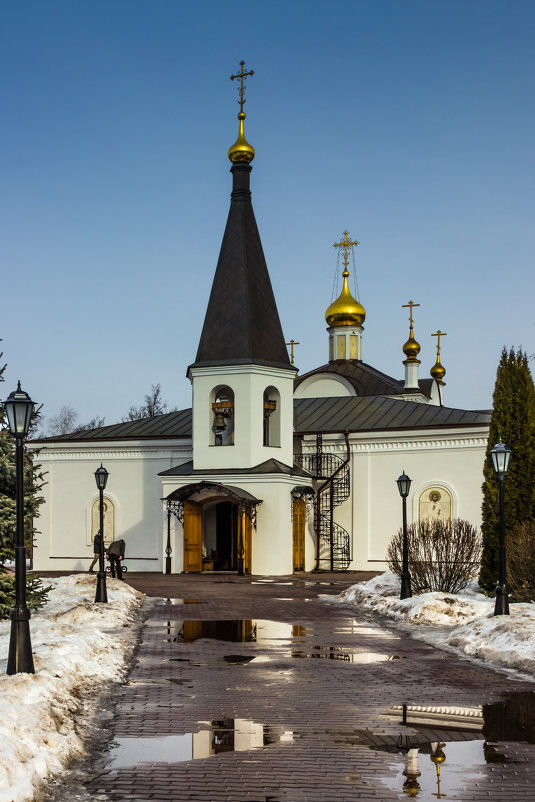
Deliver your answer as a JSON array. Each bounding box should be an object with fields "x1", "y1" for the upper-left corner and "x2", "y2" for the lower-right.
[{"x1": 192, "y1": 162, "x2": 295, "y2": 370}]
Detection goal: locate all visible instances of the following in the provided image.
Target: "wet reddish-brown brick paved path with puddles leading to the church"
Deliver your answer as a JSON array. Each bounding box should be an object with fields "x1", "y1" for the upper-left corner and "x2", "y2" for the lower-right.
[{"x1": 79, "y1": 573, "x2": 535, "y2": 802}]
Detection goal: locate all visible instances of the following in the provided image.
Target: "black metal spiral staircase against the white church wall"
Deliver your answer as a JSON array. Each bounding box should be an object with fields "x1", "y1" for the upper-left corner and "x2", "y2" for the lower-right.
[{"x1": 295, "y1": 435, "x2": 351, "y2": 571}]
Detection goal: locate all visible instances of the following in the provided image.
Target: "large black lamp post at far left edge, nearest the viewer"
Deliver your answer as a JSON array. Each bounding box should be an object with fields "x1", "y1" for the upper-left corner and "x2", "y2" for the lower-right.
[{"x1": 4, "y1": 382, "x2": 35, "y2": 674}]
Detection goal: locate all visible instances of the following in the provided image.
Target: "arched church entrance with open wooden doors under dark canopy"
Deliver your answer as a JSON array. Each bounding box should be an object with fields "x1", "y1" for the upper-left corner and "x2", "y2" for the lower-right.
[{"x1": 165, "y1": 482, "x2": 262, "y2": 575}]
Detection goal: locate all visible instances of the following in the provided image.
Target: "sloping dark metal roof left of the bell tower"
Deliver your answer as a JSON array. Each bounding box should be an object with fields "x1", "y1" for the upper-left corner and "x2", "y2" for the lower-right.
[{"x1": 34, "y1": 409, "x2": 192, "y2": 443}]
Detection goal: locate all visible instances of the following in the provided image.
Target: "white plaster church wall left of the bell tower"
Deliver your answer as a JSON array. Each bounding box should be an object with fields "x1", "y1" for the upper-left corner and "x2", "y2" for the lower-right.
[{"x1": 30, "y1": 442, "x2": 191, "y2": 571}]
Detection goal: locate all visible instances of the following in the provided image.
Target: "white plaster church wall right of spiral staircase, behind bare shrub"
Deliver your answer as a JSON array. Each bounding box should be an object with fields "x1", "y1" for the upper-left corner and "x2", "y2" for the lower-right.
[{"x1": 305, "y1": 427, "x2": 488, "y2": 570}]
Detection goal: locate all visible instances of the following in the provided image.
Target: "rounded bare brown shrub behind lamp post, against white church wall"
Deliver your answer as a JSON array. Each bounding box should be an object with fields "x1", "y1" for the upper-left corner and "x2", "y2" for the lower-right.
[{"x1": 386, "y1": 518, "x2": 481, "y2": 593}]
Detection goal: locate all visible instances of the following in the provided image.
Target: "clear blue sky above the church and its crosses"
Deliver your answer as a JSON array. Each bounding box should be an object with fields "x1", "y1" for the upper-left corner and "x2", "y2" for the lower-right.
[{"x1": 0, "y1": 0, "x2": 535, "y2": 423}]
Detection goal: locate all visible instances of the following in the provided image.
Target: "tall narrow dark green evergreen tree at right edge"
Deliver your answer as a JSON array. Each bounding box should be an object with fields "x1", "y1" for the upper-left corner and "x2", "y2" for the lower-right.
[{"x1": 479, "y1": 348, "x2": 535, "y2": 591}]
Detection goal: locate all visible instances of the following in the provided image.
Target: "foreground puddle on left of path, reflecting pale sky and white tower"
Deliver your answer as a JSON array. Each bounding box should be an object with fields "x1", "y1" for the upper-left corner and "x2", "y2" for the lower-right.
[{"x1": 110, "y1": 718, "x2": 293, "y2": 771}]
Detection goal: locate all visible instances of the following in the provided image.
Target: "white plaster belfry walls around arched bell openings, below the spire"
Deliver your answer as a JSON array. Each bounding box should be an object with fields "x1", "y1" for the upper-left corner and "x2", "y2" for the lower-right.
[{"x1": 191, "y1": 365, "x2": 294, "y2": 470}]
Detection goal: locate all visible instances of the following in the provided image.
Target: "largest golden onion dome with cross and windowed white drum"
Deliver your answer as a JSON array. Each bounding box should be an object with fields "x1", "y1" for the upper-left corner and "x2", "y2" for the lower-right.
[{"x1": 325, "y1": 231, "x2": 366, "y2": 361}]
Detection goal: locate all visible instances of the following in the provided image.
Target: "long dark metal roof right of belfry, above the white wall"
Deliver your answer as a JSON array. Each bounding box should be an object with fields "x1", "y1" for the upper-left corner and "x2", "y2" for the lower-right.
[{"x1": 294, "y1": 396, "x2": 490, "y2": 434}]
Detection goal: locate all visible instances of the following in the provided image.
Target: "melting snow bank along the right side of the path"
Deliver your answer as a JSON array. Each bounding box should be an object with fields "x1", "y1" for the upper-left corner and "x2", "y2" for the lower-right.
[{"x1": 330, "y1": 572, "x2": 535, "y2": 675}]
